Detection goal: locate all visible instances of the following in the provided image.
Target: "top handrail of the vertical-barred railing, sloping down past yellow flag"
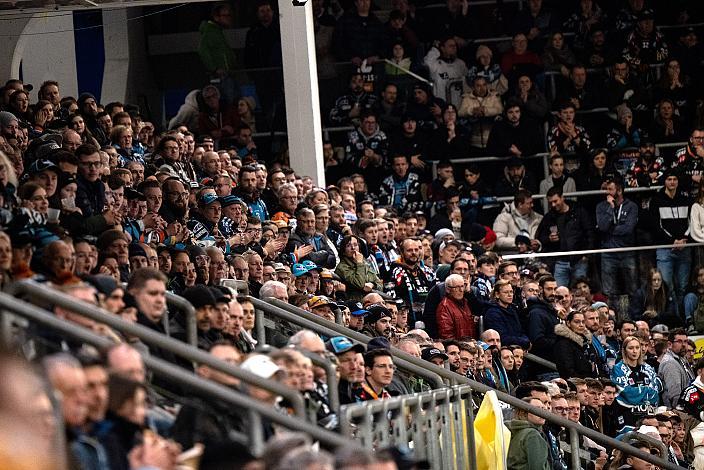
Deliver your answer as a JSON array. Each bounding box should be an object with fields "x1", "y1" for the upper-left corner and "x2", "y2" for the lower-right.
[{"x1": 341, "y1": 381, "x2": 682, "y2": 470}]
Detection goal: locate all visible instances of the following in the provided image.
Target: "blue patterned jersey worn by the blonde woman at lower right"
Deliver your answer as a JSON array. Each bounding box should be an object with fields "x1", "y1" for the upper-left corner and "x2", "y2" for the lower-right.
[{"x1": 611, "y1": 361, "x2": 662, "y2": 408}]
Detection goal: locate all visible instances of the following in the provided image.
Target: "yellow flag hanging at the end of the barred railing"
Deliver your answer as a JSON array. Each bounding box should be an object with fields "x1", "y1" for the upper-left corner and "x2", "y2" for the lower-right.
[{"x1": 474, "y1": 390, "x2": 511, "y2": 470}]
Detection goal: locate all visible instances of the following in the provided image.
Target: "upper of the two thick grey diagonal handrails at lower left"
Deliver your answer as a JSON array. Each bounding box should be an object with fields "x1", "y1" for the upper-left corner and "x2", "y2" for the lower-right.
[{"x1": 6, "y1": 279, "x2": 305, "y2": 417}]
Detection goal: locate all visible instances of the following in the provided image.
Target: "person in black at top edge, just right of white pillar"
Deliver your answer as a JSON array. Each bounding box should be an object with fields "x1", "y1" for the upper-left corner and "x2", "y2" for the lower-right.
[{"x1": 333, "y1": 0, "x2": 386, "y2": 67}]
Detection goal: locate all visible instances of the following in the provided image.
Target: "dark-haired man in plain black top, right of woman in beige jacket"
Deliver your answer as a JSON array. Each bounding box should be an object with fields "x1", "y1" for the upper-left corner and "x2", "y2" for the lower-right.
[{"x1": 486, "y1": 98, "x2": 545, "y2": 157}]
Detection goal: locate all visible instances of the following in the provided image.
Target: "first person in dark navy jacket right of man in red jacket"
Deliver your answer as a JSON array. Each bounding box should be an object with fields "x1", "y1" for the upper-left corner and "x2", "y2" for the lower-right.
[{"x1": 484, "y1": 279, "x2": 530, "y2": 348}]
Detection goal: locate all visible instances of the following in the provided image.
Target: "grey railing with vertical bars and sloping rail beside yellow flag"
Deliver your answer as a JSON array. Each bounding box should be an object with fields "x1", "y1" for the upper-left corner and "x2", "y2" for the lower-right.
[{"x1": 340, "y1": 381, "x2": 681, "y2": 470}]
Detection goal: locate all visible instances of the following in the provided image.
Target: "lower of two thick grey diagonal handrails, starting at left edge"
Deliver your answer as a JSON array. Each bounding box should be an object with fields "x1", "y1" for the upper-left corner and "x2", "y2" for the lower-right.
[{"x1": 0, "y1": 293, "x2": 349, "y2": 451}]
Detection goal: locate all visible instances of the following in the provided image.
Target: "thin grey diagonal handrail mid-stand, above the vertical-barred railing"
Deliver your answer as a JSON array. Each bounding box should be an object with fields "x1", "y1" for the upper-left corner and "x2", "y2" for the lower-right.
[{"x1": 249, "y1": 297, "x2": 446, "y2": 388}]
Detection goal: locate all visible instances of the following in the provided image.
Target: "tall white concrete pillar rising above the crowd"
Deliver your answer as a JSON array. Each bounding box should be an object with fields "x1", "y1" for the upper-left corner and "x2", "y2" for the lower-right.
[{"x1": 279, "y1": 0, "x2": 325, "y2": 186}]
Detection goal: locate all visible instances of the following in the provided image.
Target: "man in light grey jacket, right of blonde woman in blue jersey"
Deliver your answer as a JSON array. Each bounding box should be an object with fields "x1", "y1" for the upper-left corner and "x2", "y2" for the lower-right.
[{"x1": 658, "y1": 328, "x2": 694, "y2": 408}]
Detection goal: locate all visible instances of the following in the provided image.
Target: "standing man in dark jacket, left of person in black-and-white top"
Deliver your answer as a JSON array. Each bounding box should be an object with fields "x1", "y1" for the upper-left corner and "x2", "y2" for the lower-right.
[{"x1": 596, "y1": 176, "x2": 638, "y2": 298}]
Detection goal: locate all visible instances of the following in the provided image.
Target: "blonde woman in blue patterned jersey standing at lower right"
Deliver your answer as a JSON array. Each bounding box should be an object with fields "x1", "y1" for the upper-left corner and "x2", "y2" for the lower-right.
[{"x1": 611, "y1": 336, "x2": 660, "y2": 432}]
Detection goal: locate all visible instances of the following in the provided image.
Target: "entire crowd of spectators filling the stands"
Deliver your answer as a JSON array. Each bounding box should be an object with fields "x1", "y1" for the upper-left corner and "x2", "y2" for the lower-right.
[{"x1": 0, "y1": 0, "x2": 704, "y2": 470}]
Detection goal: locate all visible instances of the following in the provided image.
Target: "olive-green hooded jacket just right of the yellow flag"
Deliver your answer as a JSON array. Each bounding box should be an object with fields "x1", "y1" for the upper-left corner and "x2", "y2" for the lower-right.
[{"x1": 506, "y1": 419, "x2": 550, "y2": 470}]
